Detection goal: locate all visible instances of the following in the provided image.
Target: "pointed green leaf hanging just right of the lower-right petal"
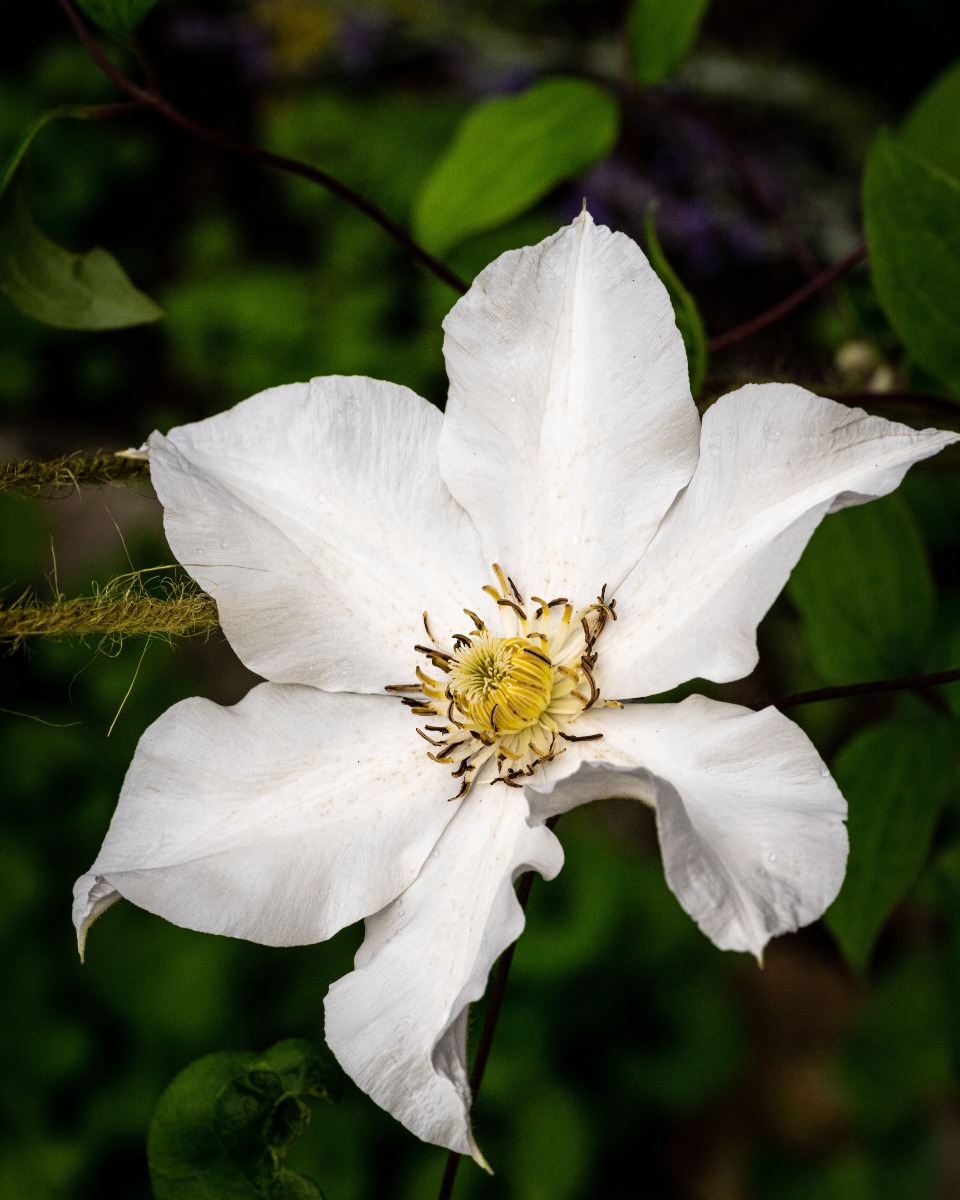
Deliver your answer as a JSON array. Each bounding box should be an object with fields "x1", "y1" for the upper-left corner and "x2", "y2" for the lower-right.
[{"x1": 826, "y1": 714, "x2": 958, "y2": 971}]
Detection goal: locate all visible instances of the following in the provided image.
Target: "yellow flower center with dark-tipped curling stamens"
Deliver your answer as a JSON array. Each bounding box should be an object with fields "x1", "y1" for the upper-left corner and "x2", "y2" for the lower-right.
[{"x1": 386, "y1": 563, "x2": 619, "y2": 800}]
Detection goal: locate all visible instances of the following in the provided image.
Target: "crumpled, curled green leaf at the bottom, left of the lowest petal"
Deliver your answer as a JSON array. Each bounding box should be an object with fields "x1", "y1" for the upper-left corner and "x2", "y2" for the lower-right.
[{"x1": 146, "y1": 1038, "x2": 343, "y2": 1200}]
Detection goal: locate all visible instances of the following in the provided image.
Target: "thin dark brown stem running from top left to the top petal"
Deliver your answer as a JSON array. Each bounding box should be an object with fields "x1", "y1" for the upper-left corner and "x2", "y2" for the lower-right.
[{"x1": 58, "y1": 0, "x2": 467, "y2": 295}]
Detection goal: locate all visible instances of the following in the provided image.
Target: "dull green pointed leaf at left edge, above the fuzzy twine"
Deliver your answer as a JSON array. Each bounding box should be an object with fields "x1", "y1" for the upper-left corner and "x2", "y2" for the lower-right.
[{"x1": 0, "y1": 193, "x2": 163, "y2": 330}]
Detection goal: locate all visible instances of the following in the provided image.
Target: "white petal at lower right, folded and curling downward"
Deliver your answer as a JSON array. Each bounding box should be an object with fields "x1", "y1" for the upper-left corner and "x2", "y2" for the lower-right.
[{"x1": 528, "y1": 696, "x2": 847, "y2": 955}]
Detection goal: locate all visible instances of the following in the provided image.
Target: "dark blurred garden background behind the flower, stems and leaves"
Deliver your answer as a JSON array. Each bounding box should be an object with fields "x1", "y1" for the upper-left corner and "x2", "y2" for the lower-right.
[{"x1": 0, "y1": 0, "x2": 960, "y2": 1200}]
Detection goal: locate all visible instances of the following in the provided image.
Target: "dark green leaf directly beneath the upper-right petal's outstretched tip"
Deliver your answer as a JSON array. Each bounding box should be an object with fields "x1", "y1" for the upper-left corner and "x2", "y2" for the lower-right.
[{"x1": 787, "y1": 494, "x2": 935, "y2": 683}]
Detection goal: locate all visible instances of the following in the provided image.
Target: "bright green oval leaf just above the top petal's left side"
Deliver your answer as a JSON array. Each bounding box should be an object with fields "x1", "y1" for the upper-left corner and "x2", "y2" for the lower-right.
[{"x1": 413, "y1": 78, "x2": 619, "y2": 254}]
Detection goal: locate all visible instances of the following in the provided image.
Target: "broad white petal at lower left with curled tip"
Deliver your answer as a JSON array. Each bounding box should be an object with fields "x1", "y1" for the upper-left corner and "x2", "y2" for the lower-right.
[{"x1": 74, "y1": 684, "x2": 456, "y2": 946}]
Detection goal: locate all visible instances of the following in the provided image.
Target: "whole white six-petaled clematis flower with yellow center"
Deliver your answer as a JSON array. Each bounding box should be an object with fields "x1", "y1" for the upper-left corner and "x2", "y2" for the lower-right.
[{"x1": 74, "y1": 214, "x2": 955, "y2": 1159}]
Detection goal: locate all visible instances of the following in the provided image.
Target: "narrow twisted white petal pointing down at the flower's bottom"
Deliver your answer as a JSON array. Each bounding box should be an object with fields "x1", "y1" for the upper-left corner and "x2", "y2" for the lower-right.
[{"x1": 326, "y1": 785, "x2": 563, "y2": 1164}]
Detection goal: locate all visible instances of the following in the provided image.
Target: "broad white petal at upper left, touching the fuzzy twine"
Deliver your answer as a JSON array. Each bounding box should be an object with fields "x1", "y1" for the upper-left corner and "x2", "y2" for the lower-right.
[{"x1": 150, "y1": 377, "x2": 488, "y2": 691}]
